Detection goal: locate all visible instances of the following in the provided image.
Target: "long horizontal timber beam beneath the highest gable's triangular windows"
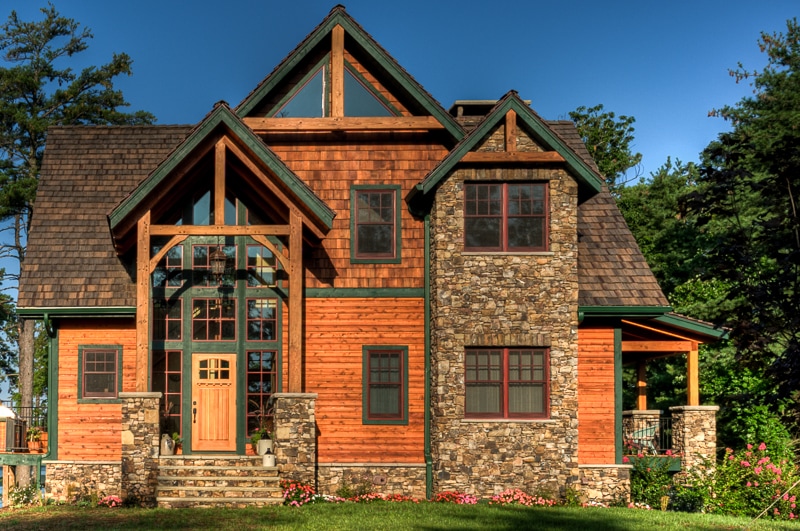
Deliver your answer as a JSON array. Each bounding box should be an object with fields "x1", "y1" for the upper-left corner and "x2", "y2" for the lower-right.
[{"x1": 243, "y1": 116, "x2": 444, "y2": 134}]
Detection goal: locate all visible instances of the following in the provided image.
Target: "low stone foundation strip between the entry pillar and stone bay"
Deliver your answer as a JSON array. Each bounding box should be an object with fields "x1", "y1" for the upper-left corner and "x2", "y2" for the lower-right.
[{"x1": 317, "y1": 463, "x2": 426, "y2": 499}]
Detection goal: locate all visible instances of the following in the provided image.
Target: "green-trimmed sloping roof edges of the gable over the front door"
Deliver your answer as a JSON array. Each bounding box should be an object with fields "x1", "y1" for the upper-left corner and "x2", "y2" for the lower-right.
[{"x1": 109, "y1": 102, "x2": 335, "y2": 249}]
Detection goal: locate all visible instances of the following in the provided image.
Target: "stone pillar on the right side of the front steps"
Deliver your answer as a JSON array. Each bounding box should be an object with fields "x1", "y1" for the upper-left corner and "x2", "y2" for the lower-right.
[{"x1": 272, "y1": 393, "x2": 317, "y2": 488}]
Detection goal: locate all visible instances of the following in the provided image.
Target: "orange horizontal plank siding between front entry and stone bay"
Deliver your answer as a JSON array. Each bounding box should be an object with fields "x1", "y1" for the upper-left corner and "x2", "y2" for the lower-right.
[{"x1": 305, "y1": 298, "x2": 425, "y2": 463}]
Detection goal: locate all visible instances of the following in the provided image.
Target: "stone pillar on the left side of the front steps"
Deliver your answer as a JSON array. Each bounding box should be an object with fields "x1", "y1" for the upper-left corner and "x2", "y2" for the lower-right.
[{"x1": 119, "y1": 393, "x2": 161, "y2": 507}]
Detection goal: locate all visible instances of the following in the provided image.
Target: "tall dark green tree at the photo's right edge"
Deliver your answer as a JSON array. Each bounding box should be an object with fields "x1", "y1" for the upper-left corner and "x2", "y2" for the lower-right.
[{"x1": 686, "y1": 19, "x2": 800, "y2": 432}]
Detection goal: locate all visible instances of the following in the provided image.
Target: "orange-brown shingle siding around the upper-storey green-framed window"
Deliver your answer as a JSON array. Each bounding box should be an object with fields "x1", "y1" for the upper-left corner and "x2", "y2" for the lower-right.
[{"x1": 266, "y1": 133, "x2": 447, "y2": 288}]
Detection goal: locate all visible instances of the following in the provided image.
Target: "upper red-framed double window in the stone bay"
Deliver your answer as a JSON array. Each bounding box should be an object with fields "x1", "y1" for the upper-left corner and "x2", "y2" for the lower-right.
[{"x1": 464, "y1": 183, "x2": 548, "y2": 251}]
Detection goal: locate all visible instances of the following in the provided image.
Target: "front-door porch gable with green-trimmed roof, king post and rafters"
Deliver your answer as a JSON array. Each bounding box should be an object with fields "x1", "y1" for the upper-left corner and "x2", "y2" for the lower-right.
[{"x1": 109, "y1": 102, "x2": 335, "y2": 254}]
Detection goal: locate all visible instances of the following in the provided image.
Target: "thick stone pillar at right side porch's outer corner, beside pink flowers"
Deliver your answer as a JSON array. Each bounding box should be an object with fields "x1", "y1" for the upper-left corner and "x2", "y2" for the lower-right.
[{"x1": 669, "y1": 406, "x2": 719, "y2": 470}]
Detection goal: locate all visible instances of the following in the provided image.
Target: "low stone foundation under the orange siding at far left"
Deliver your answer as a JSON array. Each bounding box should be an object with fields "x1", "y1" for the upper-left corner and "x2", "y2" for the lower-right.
[{"x1": 42, "y1": 461, "x2": 122, "y2": 503}]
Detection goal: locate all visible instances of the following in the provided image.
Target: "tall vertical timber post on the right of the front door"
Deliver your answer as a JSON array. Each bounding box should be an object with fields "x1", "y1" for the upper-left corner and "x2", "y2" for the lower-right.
[{"x1": 288, "y1": 209, "x2": 304, "y2": 393}]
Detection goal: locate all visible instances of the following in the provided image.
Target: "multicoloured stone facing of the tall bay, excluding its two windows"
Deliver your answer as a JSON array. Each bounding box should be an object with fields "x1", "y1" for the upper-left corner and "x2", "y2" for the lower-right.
[{"x1": 430, "y1": 126, "x2": 579, "y2": 496}]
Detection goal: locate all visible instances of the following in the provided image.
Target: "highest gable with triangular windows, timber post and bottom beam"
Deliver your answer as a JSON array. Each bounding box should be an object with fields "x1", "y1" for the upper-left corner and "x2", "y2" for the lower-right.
[{"x1": 236, "y1": 5, "x2": 464, "y2": 141}]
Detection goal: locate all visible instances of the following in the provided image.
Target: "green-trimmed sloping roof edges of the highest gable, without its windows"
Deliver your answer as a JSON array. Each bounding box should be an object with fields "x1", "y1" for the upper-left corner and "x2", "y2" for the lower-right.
[{"x1": 235, "y1": 5, "x2": 464, "y2": 141}]
